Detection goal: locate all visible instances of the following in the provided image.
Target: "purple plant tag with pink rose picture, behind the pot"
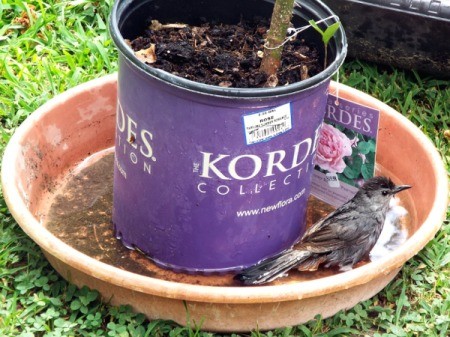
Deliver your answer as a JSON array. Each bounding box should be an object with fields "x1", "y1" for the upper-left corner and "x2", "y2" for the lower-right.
[{"x1": 311, "y1": 94, "x2": 380, "y2": 207}]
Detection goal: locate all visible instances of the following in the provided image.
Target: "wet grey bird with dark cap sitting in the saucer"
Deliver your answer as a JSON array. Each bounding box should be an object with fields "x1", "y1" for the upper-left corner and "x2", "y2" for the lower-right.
[{"x1": 234, "y1": 177, "x2": 411, "y2": 285}]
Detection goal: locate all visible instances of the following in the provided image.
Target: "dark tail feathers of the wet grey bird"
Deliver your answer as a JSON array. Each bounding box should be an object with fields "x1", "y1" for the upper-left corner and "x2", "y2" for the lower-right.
[{"x1": 234, "y1": 249, "x2": 311, "y2": 285}]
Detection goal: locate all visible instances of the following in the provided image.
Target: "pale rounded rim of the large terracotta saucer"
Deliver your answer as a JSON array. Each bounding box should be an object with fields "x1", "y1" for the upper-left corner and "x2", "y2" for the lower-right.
[{"x1": 1, "y1": 74, "x2": 448, "y2": 304}]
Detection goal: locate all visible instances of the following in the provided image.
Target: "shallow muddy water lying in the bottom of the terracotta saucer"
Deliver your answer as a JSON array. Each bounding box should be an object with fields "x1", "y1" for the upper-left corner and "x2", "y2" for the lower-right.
[{"x1": 43, "y1": 151, "x2": 412, "y2": 286}]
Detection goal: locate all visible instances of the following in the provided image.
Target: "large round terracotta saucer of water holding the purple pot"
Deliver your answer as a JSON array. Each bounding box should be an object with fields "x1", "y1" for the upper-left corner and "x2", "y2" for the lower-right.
[{"x1": 2, "y1": 75, "x2": 448, "y2": 332}]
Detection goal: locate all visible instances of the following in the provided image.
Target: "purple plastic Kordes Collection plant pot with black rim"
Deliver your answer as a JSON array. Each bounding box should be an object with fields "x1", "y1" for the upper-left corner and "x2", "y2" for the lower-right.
[{"x1": 110, "y1": 0, "x2": 347, "y2": 272}]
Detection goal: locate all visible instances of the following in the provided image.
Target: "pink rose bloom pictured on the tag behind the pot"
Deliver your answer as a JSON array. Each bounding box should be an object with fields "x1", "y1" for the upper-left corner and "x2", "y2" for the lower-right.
[{"x1": 315, "y1": 123, "x2": 352, "y2": 173}]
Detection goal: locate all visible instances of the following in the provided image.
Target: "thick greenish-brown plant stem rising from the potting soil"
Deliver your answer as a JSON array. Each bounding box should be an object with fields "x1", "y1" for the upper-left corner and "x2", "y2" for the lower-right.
[{"x1": 260, "y1": 0, "x2": 294, "y2": 77}]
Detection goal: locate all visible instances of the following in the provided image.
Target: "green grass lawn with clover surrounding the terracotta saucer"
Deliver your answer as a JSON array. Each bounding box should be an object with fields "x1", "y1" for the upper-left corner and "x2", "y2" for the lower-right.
[{"x1": 0, "y1": 0, "x2": 450, "y2": 337}]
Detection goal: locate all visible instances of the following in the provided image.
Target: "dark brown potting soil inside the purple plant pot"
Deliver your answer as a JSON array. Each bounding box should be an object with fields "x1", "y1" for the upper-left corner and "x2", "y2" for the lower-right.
[{"x1": 127, "y1": 18, "x2": 322, "y2": 88}]
